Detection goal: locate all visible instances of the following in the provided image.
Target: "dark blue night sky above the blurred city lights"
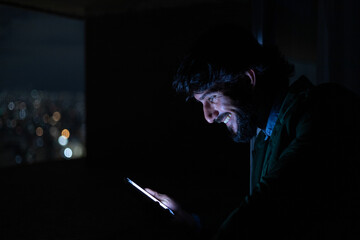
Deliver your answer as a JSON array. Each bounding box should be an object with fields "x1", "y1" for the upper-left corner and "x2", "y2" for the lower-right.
[{"x1": 0, "y1": 5, "x2": 85, "y2": 91}]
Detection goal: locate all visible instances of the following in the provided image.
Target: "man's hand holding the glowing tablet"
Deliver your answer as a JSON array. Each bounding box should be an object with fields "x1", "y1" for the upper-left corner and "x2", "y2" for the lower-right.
[{"x1": 145, "y1": 188, "x2": 200, "y2": 230}]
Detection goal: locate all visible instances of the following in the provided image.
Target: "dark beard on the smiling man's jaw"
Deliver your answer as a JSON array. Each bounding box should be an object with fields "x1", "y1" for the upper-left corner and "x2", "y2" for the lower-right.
[{"x1": 229, "y1": 107, "x2": 257, "y2": 143}]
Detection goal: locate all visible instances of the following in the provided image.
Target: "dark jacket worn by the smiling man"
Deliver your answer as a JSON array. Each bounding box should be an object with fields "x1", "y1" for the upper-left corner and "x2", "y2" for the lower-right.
[{"x1": 217, "y1": 77, "x2": 360, "y2": 239}]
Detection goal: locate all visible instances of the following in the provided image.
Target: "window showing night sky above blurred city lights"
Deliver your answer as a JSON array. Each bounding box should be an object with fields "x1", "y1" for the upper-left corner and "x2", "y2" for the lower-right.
[{"x1": 0, "y1": 5, "x2": 86, "y2": 167}]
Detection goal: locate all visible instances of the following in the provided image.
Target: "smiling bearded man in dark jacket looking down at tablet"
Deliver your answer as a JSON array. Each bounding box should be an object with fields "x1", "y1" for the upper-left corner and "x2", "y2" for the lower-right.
[{"x1": 147, "y1": 26, "x2": 360, "y2": 239}]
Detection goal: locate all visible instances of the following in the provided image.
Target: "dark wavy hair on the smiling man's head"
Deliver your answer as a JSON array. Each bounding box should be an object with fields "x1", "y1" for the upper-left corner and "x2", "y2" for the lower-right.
[{"x1": 173, "y1": 25, "x2": 294, "y2": 101}]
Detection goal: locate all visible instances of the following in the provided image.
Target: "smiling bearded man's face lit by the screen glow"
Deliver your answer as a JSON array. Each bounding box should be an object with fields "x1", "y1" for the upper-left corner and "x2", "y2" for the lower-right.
[{"x1": 194, "y1": 91, "x2": 257, "y2": 142}]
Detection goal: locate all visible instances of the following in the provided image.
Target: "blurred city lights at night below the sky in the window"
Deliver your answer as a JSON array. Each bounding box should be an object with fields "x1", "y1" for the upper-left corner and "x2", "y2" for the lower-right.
[{"x1": 0, "y1": 90, "x2": 86, "y2": 166}]
